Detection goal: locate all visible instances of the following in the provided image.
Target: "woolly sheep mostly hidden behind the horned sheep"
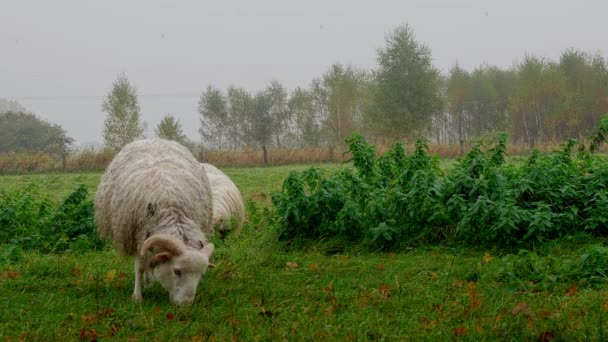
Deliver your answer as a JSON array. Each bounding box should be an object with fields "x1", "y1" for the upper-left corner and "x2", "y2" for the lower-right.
[{"x1": 202, "y1": 163, "x2": 245, "y2": 232}]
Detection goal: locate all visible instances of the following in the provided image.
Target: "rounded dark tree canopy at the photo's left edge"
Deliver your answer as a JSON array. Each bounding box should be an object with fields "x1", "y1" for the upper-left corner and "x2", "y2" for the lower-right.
[{"x1": 0, "y1": 112, "x2": 74, "y2": 157}]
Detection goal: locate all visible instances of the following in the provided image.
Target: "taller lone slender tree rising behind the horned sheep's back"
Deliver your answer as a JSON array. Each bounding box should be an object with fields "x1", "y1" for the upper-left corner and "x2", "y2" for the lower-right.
[{"x1": 102, "y1": 74, "x2": 145, "y2": 151}]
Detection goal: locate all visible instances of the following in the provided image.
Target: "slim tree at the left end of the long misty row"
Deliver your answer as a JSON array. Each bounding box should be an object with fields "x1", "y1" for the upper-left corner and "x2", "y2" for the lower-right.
[{"x1": 198, "y1": 85, "x2": 229, "y2": 148}]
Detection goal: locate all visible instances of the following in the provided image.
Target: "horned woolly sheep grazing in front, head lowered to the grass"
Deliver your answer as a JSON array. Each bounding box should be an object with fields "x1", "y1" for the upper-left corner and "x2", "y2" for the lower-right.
[{"x1": 95, "y1": 139, "x2": 214, "y2": 305}]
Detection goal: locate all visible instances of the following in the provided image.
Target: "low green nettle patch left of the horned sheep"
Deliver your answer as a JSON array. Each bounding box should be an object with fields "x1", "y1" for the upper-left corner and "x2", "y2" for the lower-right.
[{"x1": 0, "y1": 184, "x2": 104, "y2": 255}]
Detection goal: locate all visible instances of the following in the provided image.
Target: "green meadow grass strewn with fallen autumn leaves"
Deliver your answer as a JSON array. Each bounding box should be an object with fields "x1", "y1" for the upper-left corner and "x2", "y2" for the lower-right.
[{"x1": 0, "y1": 164, "x2": 608, "y2": 341}]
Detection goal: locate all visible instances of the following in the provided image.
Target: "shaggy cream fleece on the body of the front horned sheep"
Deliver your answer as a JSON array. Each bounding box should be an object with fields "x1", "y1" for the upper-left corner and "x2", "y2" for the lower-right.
[{"x1": 95, "y1": 139, "x2": 213, "y2": 255}]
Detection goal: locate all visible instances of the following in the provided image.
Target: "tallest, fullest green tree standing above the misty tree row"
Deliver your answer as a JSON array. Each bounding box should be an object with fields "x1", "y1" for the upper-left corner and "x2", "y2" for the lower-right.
[{"x1": 366, "y1": 25, "x2": 443, "y2": 138}]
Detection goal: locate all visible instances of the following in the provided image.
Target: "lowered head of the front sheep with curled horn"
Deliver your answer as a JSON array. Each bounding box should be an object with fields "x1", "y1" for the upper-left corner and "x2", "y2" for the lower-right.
[{"x1": 141, "y1": 234, "x2": 215, "y2": 305}]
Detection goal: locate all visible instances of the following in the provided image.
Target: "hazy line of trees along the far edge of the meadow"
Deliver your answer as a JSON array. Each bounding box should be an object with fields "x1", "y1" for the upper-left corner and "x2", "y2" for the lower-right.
[{"x1": 4, "y1": 25, "x2": 608, "y2": 160}]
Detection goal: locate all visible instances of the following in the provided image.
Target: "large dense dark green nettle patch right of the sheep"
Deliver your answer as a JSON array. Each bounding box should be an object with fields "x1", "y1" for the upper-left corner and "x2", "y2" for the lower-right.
[{"x1": 272, "y1": 133, "x2": 608, "y2": 249}]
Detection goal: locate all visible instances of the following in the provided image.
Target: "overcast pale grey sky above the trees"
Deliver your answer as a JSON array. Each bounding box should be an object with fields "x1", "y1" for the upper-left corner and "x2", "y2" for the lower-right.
[{"x1": 0, "y1": 0, "x2": 608, "y2": 145}]
